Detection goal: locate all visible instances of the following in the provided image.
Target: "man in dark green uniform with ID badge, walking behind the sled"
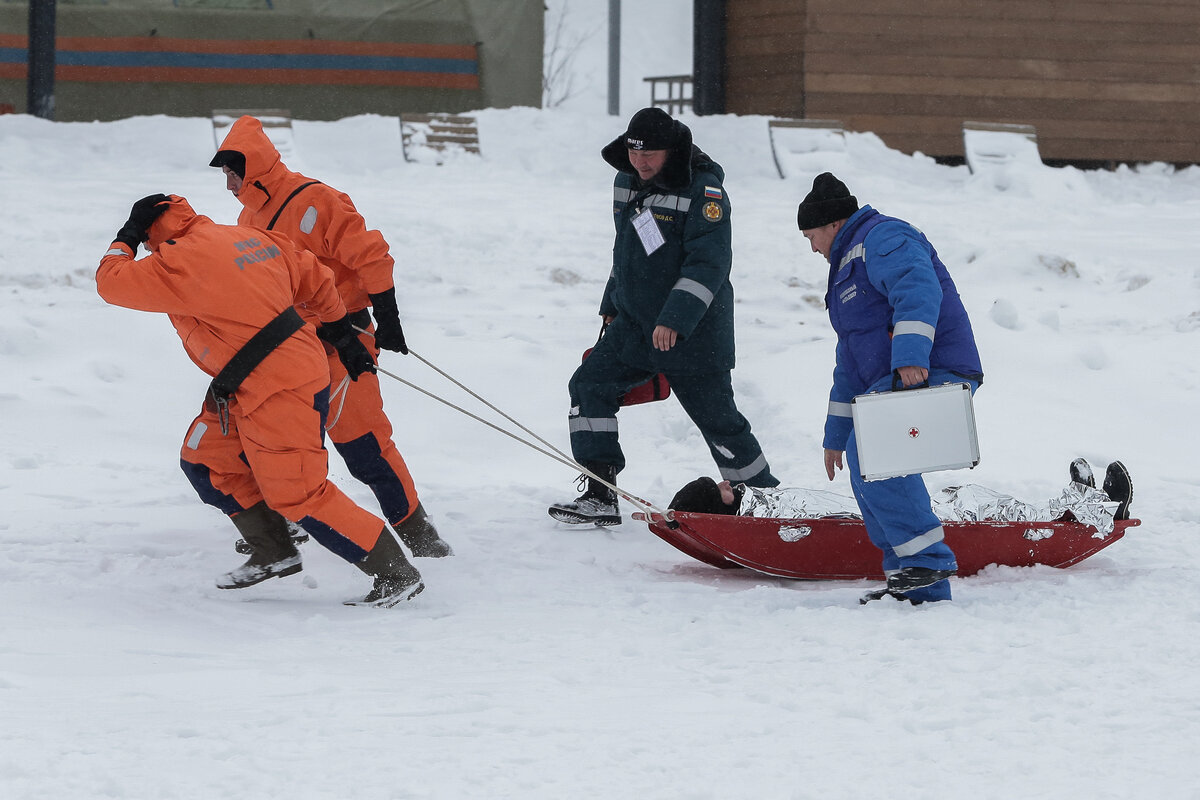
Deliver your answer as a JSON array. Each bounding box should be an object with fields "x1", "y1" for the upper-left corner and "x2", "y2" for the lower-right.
[{"x1": 550, "y1": 108, "x2": 779, "y2": 525}]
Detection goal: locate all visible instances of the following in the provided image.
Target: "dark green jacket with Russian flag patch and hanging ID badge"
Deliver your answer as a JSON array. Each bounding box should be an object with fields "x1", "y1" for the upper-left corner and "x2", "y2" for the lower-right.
[{"x1": 600, "y1": 128, "x2": 734, "y2": 374}]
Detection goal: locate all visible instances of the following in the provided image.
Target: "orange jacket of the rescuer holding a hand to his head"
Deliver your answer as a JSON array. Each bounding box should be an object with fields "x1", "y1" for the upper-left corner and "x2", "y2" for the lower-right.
[{"x1": 96, "y1": 196, "x2": 346, "y2": 413}]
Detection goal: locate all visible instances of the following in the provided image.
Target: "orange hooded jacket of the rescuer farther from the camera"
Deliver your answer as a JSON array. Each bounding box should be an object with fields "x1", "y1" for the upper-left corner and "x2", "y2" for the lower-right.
[{"x1": 218, "y1": 116, "x2": 395, "y2": 320}]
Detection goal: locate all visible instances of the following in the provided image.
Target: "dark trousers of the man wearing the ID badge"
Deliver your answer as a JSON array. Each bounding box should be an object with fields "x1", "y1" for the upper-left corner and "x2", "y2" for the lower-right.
[{"x1": 568, "y1": 336, "x2": 779, "y2": 487}]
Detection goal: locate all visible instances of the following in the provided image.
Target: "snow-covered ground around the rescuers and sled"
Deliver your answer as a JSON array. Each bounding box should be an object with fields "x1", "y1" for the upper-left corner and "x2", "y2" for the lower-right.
[{"x1": 0, "y1": 4, "x2": 1200, "y2": 800}]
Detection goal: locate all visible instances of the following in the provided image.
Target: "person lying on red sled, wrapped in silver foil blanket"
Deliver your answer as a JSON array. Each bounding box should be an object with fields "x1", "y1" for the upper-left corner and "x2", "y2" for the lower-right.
[{"x1": 671, "y1": 458, "x2": 1133, "y2": 534}]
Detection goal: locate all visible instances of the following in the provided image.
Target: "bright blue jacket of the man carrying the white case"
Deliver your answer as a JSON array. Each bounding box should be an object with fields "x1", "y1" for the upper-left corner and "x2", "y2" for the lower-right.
[{"x1": 824, "y1": 205, "x2": 983, "y2": 450}]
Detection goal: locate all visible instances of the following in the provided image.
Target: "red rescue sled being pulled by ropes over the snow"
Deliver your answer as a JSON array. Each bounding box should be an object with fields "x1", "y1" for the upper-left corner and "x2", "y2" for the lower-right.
[{"x1": 634, "y1": 511, "x2": 1141, "y2": 581}]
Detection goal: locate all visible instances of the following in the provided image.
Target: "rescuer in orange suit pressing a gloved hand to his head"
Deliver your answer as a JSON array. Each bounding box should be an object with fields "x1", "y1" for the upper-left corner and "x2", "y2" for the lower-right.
[{"x1": 96, "y1": 194, "x2": 425, "y2": 606}]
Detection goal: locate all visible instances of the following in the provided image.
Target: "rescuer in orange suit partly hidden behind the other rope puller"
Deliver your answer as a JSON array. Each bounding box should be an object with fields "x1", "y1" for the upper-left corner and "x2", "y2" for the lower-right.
[{"x1": 204, "y1": 116, "x2": 452, "y2": 558}]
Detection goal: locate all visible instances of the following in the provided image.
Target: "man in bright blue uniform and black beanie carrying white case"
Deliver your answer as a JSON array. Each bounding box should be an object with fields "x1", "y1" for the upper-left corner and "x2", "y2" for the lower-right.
[{"x1": 797, "y1": 173, "x2": 983, "y2": 603}]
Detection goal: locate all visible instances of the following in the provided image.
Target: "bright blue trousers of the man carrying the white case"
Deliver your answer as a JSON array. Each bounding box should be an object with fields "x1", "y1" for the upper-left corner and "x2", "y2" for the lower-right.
[{"x1": 846, "y1": 369, "x2": 979, "y2": 602}]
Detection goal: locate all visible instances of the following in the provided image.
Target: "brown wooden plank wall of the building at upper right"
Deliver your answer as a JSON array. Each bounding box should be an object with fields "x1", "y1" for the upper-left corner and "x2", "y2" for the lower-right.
[{"x1": 725, "y1": 0, "x2": 1200, "y2": 163}]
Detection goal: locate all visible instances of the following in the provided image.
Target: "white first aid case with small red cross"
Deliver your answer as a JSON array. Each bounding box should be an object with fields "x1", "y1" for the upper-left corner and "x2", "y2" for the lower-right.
[{"x1": 851, "y1": 384, "x2": 979, "y2": 481}]
